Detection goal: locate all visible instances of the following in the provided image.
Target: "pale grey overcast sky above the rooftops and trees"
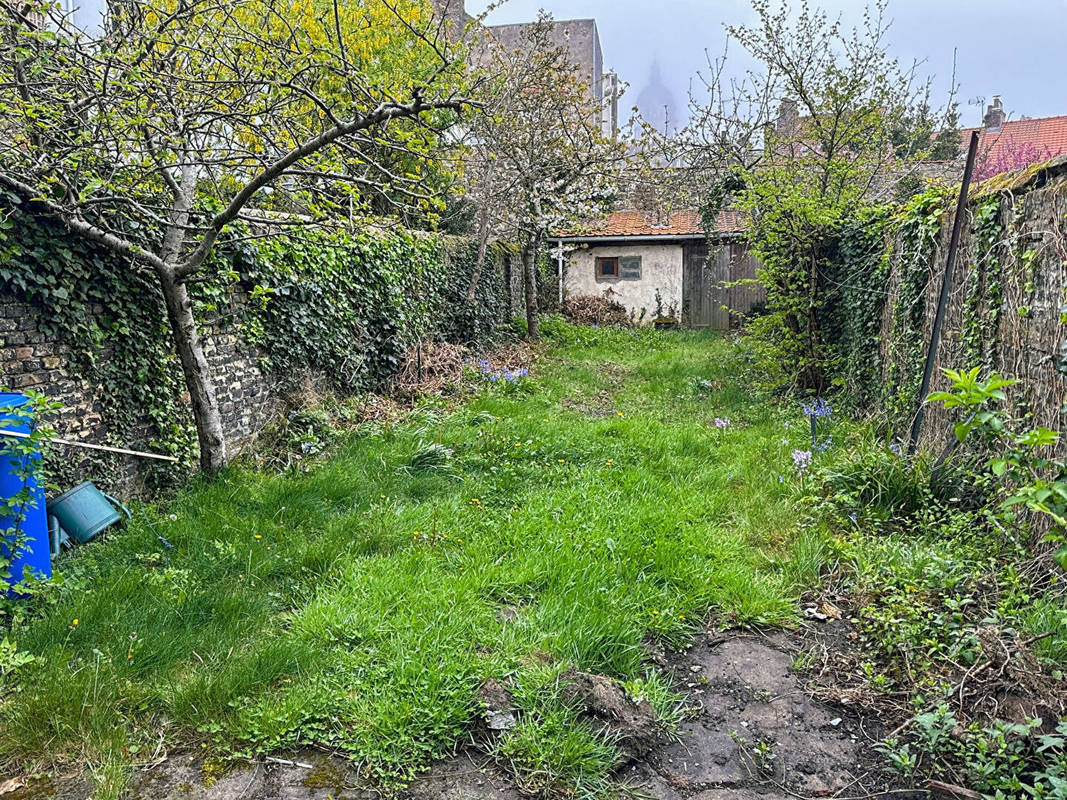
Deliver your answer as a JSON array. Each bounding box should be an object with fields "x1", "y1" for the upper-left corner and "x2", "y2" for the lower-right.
[{"x1": 467, "y1": 0, "x2": 1067, "y2": 126}]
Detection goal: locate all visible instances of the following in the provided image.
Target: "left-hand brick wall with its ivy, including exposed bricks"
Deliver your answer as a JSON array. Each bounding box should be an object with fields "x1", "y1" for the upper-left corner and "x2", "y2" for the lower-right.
[{"x1": 0, "y1": 207, "x2": 511, "y2": 494}]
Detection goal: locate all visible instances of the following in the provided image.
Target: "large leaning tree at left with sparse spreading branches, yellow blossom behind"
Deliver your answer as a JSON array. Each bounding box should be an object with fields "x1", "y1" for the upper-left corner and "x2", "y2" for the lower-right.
[{"x1": 0, "y1": 0, "x2": 466, "y2": 473}]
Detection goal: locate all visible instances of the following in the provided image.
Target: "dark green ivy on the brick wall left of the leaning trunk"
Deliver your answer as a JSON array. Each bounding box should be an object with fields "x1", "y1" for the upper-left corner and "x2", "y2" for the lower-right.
[{"x1": 0, "y1": 198, "x2": 195, "y2": 482}]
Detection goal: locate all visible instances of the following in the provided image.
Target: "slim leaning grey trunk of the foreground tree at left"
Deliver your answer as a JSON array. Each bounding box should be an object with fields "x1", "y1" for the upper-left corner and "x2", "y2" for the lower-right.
[{"x1": 159, "y1": 269, "x2": 226, "y2": 475}]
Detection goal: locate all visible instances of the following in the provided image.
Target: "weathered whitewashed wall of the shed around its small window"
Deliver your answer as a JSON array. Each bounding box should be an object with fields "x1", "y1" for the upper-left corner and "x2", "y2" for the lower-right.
[{"x1": 563, "y1": 243, "x2": 682, "y2": 324}]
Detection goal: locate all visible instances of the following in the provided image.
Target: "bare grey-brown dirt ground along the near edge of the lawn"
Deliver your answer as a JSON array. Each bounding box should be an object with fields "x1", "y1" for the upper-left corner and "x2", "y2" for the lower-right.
[{"x1": 12, "y1": 623, "x2": 913, "y2": 800}]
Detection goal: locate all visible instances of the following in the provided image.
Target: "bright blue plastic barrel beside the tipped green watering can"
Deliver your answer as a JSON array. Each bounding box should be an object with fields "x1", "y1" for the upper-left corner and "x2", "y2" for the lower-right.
[{"x1": 0, "y1": 391, "x2": 52, "y2": 586}]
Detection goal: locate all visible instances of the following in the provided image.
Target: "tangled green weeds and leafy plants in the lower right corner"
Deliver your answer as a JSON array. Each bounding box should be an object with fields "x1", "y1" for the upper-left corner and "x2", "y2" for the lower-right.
[{"x1": 808, "y1": 370, "x2": 1067, "y2": 798}]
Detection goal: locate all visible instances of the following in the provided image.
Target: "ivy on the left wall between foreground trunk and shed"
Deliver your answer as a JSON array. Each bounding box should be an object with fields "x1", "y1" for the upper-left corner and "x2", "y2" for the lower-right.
[{"x1": 234, "y1": 230, "x2": 506, "y2": 393}]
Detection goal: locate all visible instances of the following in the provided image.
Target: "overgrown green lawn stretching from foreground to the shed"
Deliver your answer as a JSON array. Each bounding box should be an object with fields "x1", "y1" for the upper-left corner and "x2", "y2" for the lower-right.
[{"x1": 0, "y1": 323, "x2": 823, "y2": 794}]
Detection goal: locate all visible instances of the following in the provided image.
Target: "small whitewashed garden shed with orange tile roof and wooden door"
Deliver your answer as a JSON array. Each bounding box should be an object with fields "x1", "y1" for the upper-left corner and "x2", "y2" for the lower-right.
[{"x1": 555, "y1": 210, "x2": 765, "y2": 331}]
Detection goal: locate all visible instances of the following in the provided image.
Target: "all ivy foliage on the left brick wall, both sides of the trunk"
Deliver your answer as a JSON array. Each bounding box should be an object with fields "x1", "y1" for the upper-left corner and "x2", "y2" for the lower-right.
[{"x1": 0, "y1": 204, "x2": 507, "y2": 489}]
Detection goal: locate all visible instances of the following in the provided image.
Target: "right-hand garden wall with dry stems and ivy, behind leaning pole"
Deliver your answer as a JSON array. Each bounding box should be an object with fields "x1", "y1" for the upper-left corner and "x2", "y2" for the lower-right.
[{"x1": 840, "y1": 154, "x2": 1067, "y2": 449}]
